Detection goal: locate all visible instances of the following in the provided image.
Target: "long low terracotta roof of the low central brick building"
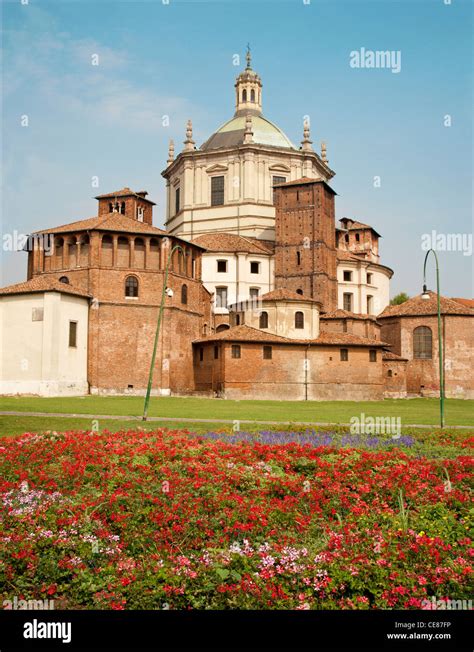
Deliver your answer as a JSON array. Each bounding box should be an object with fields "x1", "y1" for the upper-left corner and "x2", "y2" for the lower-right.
[{"x1": 194, "y1": 325, "x2": 389, "y2": 348}]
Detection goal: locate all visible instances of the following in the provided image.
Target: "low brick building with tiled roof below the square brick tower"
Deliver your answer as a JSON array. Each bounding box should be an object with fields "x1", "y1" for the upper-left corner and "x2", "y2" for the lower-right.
[{"x1": 193, "y1": 325, "x2": 384, "y2": 401}]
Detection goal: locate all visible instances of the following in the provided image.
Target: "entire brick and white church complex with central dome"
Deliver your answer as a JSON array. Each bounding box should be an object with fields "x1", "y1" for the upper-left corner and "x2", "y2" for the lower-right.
[{"x1": 0, "y1": 52, "x2": 474, "y2": 400}]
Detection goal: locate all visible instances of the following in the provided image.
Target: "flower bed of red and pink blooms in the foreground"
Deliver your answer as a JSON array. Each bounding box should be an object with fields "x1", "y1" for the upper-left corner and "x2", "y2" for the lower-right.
[{"x1": 0, "y1": 430, "x2": 472, "y2": 609}]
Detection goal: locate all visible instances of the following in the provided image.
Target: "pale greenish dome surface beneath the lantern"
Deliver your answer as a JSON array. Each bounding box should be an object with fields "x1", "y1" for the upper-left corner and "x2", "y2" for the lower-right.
[{"x1": 201, "y1": 111, "x2": 296, "y2": 151}]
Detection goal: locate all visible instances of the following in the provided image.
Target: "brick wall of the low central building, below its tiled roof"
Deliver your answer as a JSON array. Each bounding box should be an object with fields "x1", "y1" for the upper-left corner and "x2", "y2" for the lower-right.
[{"x1": 194, "y1": 342, "x2": 383, "y2": 400}]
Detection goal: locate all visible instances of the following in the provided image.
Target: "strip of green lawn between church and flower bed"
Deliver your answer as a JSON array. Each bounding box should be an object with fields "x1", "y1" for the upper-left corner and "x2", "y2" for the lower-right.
[{"x1": 0, "y1": 396, "x2": 474, "y2": 429}]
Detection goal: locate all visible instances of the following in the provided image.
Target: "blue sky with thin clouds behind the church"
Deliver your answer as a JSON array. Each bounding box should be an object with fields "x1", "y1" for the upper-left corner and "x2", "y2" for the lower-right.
[{"x1": 1, "y1": 0, "x2": 473, "y2": 296}]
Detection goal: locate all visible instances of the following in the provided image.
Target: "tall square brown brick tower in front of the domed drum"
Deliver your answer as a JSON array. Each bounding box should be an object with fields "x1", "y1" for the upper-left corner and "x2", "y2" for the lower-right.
[{"x1": 275, "y1": 178, "x2": 337, "y2": 312}]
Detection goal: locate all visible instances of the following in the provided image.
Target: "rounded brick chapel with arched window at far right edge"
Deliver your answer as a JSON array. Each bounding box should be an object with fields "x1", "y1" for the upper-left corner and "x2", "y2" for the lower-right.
[{"x1": 377, "y1": 292, "x2": 474, "y2": 399}]
